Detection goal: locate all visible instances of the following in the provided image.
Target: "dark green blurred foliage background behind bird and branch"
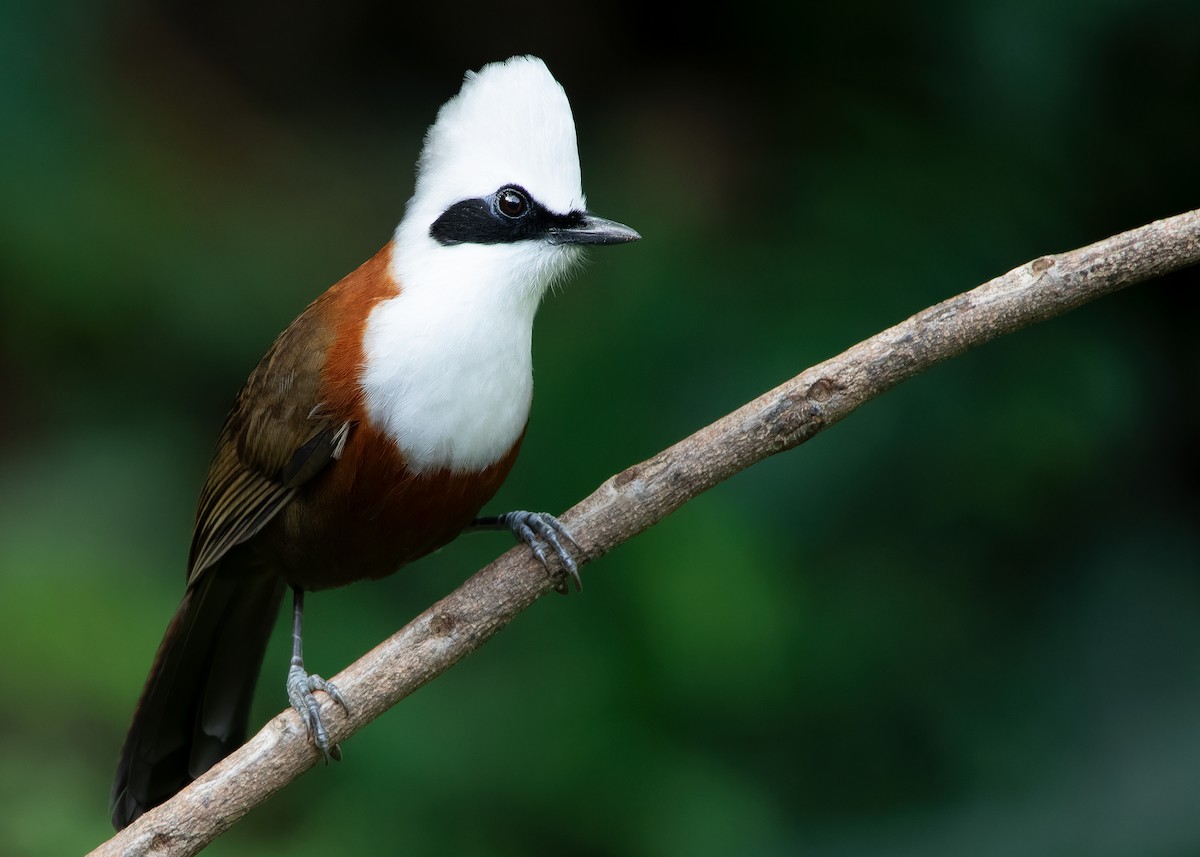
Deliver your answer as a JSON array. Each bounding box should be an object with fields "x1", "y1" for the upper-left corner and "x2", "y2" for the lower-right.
[{"x1": 0, "y1": 0, "x2": 1200, "y2": 857}]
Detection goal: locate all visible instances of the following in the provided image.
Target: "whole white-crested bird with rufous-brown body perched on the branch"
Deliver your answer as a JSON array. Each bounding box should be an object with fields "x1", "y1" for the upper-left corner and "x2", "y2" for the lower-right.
[{"x1": 110, "y1": 55, "x2": 640, "y2": 829}]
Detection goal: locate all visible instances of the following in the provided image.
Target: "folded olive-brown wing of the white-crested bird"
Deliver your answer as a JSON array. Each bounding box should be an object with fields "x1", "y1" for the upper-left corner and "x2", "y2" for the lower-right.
[{"x1": 187, "y1": 299, "x2": 352, "y2": 585}]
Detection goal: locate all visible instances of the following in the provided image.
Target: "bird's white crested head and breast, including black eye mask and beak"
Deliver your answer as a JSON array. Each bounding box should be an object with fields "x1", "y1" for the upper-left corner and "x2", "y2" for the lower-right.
[{"x1": 360, "y1": 56, "x2": 638, "y2": 472}]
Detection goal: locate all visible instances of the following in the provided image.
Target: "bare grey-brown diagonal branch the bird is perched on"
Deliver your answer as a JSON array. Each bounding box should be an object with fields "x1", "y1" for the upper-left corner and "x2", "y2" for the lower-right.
[{"x1": 92, "y1": 209, "x2": 1200, "y2": 856}]
